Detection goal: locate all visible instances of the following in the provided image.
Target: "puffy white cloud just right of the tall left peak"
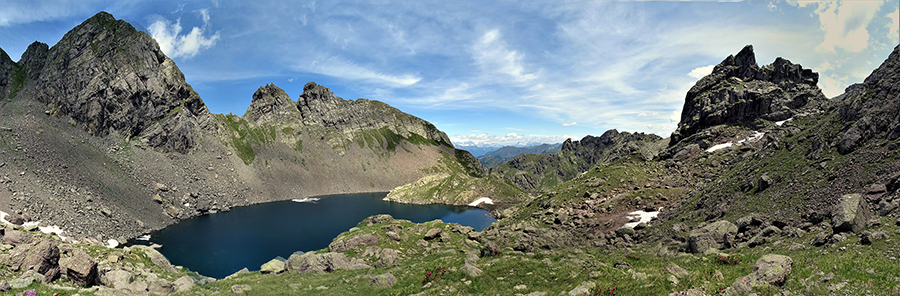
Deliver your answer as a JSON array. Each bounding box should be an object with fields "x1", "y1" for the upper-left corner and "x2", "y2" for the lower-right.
[{"x1": 147, "y1": 9, "x2": 219, "y2": 59}]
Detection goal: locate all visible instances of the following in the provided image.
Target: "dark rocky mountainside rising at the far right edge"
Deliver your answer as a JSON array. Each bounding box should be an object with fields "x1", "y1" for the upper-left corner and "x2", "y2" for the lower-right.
[{"x1": 835, "y1": 46, "x2": 900, "y2": 154}]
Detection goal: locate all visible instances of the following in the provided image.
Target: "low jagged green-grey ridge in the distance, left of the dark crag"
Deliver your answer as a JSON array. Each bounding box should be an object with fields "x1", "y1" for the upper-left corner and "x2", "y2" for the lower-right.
[{"x1": 490, "y1": 129, "x2": 662, "y2": 191}]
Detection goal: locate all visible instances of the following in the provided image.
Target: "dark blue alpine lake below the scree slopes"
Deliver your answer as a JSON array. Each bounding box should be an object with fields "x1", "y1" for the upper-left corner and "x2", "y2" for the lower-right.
[{"x1": 132, "y1": 193, "x2": 496, "y2": 278}]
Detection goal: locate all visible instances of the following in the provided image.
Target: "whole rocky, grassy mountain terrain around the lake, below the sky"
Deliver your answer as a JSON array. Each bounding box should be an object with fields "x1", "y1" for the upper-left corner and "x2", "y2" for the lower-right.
[{"x1": 0, "y1": 9, "x2": 900, "y2": 296}]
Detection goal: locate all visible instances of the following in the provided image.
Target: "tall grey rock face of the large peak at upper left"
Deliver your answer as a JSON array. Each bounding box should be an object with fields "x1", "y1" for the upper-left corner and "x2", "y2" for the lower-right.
[{"x1": 19, "y1": 12, "x2": 215, "y2": 153}]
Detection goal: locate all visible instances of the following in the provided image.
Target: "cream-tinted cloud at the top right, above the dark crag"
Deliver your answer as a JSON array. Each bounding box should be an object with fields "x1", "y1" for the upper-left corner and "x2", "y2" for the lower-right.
[{"x1": 788, "y1": 0, "x2": 888, "y2": 52}]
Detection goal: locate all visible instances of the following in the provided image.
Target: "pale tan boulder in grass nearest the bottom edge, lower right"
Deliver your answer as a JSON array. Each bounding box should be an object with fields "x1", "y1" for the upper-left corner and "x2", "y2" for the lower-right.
[{"x1": 725, "y1": 254, "x2": 794, "y2": 295}]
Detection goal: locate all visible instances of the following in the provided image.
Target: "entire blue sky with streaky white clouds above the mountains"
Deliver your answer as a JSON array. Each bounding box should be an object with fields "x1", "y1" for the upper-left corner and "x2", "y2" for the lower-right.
[{"x1": 0, "y1": 0, "x2": 900, "y2": 144}]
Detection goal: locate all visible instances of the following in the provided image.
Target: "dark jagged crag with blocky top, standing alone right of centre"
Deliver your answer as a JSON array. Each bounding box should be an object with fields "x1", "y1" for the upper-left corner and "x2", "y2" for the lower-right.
[{"x1": 669, "y1": 45, "x2": 827, "y2": 146}]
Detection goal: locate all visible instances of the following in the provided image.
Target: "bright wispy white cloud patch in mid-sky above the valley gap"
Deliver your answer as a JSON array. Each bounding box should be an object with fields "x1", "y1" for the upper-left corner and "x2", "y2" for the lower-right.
[{"x1": 472, "y1": 29, "x2": 536, "y2": 82}]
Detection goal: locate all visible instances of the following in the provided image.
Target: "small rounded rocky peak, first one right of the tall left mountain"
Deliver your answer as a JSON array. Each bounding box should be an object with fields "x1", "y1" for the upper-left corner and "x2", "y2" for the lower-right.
[{"x1": 244, "y1": 84, "x2": 300, "y2": 123}]
